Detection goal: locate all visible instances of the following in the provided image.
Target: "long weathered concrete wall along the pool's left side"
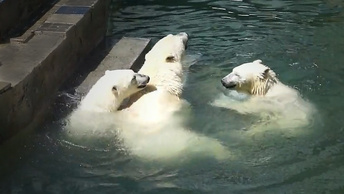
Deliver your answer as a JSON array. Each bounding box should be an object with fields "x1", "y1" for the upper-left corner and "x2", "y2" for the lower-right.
[{"x1": 0, "y1": 0, "x2": 109, "y2": 143}]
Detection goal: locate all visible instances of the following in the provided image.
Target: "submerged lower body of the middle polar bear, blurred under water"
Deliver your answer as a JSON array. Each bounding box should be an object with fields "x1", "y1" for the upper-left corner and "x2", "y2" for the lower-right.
[{"x1": 119, "y1": 114, "x2": 231, "y2": 162}]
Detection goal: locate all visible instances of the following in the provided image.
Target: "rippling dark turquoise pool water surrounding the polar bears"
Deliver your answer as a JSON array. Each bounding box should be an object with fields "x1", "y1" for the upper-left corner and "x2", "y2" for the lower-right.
[{"x1": 0, "y1": 0, "x2": 344, "y2": 193}]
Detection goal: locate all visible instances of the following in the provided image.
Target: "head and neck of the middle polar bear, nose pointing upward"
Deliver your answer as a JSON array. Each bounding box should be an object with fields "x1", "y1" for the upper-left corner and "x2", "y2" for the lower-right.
[{"x1": 139, "y1": 32, "x2": 188, "y2": 96}]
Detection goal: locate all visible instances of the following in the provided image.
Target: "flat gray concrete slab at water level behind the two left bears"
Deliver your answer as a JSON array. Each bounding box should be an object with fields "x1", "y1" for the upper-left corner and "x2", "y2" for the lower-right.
[{"x1": 76, "y1": 37, "x2": 151, "y2": 94}]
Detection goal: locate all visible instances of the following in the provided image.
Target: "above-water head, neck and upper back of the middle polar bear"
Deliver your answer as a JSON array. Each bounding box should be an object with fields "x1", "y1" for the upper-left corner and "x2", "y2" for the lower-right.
[{"x1": 123, "y1": 32, "x2": 188, "y2": 124}]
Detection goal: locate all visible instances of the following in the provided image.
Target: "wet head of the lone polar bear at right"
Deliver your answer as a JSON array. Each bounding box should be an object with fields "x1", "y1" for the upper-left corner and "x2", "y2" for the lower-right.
[{"x1": 221, "y1": 60, "x2": 278, "y2": 96}]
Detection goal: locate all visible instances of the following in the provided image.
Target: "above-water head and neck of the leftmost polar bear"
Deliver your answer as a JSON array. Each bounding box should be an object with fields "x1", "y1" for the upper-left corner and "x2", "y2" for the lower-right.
[{"x1": 78, "y1": 69, "x2": 150, "y2": 112}]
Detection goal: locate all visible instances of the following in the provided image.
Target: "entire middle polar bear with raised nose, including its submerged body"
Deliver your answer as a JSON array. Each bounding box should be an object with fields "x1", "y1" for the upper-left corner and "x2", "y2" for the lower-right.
[{"x1": 120, "y1": 32, "x2": 229, "y2": 161}]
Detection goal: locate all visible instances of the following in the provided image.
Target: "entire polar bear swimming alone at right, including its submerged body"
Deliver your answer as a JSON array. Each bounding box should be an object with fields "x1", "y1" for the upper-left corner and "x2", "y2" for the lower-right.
[{"x1": 212, "y1": 60, "x2": 315, "y2": 133}]
